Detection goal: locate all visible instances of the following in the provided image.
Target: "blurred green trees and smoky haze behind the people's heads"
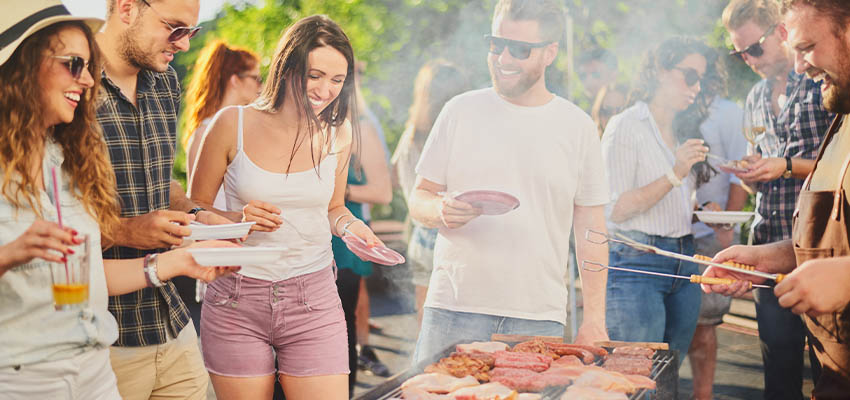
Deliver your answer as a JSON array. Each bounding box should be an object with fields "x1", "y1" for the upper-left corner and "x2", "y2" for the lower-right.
[{"x1": 174, "y1": 0, "x2": 758, "y2": 225}]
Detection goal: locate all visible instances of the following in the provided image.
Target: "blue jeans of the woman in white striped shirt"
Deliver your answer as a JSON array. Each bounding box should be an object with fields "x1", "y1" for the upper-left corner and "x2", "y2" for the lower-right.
[{"x1": 605, "y1": 231, "x2": 702, "y2": 365}]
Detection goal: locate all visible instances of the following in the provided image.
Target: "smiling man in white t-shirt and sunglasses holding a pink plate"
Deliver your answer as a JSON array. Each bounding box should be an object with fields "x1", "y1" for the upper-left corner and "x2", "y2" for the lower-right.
[{"x1": 410, "y1": 0, "x2": 609, "y2": 362}]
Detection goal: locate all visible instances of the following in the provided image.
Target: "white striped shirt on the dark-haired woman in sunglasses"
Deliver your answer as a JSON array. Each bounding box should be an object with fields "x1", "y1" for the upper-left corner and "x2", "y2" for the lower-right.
[{"x1": 602, "y1": 102, "x2": 696, "y2": 237}]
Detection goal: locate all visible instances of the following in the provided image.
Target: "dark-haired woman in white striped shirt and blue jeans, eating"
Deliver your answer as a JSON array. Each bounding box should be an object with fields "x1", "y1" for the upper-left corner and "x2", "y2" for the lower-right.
[{"x1": 600, "y1": 37, "x2": 714, "y2": 362}]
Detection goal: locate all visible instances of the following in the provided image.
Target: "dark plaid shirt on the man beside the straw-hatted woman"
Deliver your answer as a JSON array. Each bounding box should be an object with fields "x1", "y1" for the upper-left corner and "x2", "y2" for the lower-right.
[{"x1": 97, "y1": 67, "x2": 190, "y2": 346}]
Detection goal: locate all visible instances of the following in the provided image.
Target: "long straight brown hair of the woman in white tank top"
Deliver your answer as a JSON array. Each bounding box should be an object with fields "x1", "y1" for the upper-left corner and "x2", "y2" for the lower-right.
[{"x1": 254, "y1": 15, "x2": 360, "y2": 173}]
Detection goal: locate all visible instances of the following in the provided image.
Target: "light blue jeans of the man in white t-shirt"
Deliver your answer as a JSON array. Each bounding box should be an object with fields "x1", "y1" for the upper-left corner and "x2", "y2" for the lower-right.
[{"x1": 413, "y1": 307, "x2": 564, "y2": 364}]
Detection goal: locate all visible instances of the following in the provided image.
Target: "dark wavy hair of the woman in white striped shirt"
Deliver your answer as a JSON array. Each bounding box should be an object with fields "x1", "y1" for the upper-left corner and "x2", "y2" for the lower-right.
[{"x1": 627, "y1": 37, "x2": 722, "y2": 186}]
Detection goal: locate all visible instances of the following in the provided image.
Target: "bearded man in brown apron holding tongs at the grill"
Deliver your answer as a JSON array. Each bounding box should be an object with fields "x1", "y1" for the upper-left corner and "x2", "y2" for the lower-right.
[{"x1": 703, "y1": 0, "x2": 850, "y2": 400}]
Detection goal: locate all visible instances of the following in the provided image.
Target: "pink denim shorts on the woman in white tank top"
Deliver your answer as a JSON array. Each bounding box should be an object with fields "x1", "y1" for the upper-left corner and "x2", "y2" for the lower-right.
[{"x1": 201, "y1": 267, "x2": 349, "y2": 377}]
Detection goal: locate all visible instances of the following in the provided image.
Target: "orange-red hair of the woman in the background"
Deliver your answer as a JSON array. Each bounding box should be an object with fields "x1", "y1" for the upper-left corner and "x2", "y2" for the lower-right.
[{"x1": 183, "y1": 40, "x2": 259, "y2": 147}]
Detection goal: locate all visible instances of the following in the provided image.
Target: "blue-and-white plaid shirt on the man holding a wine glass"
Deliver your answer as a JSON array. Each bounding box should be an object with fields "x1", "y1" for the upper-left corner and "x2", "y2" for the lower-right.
[{"x1": 745, "y1": 72, "x2": 834, "y2": 244}]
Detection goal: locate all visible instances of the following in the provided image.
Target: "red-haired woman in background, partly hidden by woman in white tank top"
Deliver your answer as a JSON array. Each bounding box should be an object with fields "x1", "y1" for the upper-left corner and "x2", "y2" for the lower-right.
[{"x1": 174, "y1": 40, "x2": 263, "y2": 330}]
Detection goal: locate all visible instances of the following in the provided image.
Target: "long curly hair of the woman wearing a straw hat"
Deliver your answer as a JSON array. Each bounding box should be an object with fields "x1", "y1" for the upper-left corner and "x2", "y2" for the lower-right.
[{"x1": 0, "y1": 21, "x2": 118, "y2": 244}]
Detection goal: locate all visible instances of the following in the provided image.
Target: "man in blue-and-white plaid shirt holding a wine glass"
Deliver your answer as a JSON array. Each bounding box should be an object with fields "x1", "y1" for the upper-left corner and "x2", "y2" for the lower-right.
[{"x1": 723, "y1": 0, "x2": 834, "y2": 400}]
